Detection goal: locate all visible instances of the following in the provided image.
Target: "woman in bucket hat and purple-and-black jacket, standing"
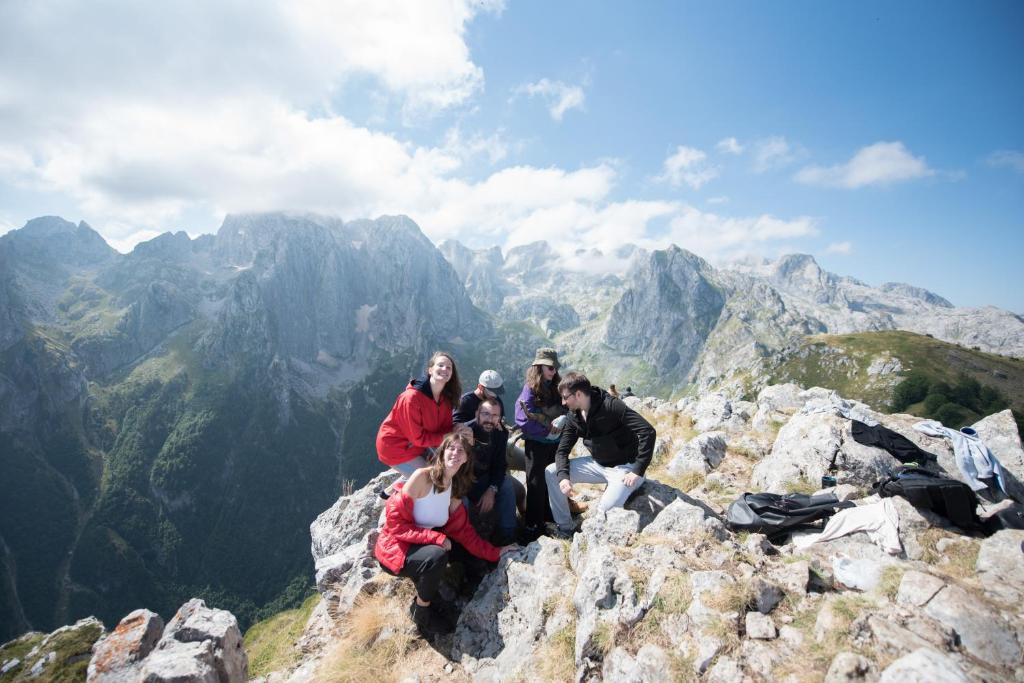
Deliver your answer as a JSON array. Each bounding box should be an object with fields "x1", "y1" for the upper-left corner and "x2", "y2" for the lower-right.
[{"x1": 515, "y1": 347, "x2": 565, "y2": 538}]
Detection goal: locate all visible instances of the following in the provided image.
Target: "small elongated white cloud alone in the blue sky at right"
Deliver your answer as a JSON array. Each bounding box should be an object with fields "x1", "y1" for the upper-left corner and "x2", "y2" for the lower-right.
[{"x1": 796, "y1": 142, "x2": 935, "y2": 189}]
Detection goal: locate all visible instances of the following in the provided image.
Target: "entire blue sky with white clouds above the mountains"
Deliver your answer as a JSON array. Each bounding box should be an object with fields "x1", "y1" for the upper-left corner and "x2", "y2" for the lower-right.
[{"x1": 0, "y1": 0, "x2": 1024, "y2": 312}]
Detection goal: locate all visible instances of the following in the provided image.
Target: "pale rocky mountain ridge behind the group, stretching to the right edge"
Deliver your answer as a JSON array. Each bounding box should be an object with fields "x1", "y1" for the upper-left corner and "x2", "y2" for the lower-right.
[{"x1": 440, "y1": 241, "x2": 1024, "y2": 393}]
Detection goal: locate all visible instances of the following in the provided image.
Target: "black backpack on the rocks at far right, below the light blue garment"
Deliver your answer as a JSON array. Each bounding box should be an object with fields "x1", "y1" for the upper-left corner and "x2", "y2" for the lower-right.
[{"x1": 873, "y1": 467, "x2": 980, "y2": 531}]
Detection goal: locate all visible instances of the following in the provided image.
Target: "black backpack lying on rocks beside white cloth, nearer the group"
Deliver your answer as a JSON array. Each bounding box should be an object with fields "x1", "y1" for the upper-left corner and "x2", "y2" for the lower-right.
[{"x1": 725, "y1": 494, "x2": 854, "y2": 540}]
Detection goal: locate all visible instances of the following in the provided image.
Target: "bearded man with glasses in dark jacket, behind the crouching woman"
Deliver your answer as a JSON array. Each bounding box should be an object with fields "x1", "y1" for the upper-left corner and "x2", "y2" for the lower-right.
[{"x1": 466, "y1": 398, "x2": 522, "y2": 545}]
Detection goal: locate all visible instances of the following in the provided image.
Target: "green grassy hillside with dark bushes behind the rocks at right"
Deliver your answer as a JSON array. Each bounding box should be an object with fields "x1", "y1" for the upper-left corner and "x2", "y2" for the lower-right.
[{"x1": 770, "y1": 331, "x2": 1024, "y2": 432}]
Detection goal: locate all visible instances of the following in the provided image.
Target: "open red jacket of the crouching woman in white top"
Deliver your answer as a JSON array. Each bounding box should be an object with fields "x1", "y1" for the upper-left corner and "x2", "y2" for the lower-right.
[{"x1": 374, "y1": 483, "x2": 501, "y2": 573}]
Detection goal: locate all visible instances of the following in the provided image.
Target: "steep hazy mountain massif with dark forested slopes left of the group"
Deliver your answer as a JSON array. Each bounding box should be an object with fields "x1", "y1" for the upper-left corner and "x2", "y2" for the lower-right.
[{"x1": 0, "y1": 214, "x2": 544, "y2": 640}]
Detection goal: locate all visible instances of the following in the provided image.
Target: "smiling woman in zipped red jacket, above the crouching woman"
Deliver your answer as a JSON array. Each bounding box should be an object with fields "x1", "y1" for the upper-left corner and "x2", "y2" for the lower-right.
[{"x1": 377, "y1": 351, "x2": 468, "y2": 491}]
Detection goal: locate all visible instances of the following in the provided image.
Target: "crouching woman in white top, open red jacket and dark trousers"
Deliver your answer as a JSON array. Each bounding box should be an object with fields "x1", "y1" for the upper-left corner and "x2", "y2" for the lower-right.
[{"x1": 374, "y1": 433, "x2": 517, "y2": 635}]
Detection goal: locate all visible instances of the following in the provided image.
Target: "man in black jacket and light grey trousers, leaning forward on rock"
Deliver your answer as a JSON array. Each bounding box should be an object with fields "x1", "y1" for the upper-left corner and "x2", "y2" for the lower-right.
[{"x1": 545, "y1": 373, "x2": 656, "y2": 538}]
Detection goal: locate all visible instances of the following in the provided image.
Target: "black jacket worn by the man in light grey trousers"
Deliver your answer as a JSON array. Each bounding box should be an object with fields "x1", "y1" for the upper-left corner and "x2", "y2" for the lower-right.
[{"x1": 555, "y1": 387, "x2": 655, "y2": 479}]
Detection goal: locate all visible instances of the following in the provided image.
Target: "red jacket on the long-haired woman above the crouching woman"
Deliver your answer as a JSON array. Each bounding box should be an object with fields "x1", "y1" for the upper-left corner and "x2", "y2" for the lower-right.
[{"x1": 377, "y1": 378, "x2": 452, "y2": 467}]
